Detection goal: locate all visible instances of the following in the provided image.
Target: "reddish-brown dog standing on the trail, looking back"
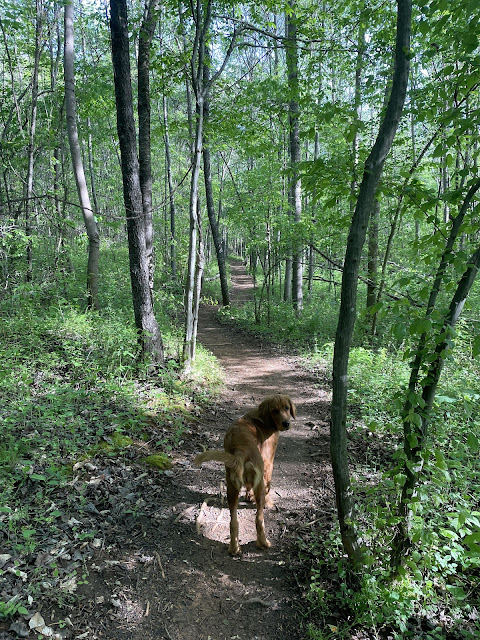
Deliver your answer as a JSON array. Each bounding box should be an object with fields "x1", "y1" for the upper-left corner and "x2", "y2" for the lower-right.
[{"x1": 195, "y1": 394, "x2": 296, "y2": 556}]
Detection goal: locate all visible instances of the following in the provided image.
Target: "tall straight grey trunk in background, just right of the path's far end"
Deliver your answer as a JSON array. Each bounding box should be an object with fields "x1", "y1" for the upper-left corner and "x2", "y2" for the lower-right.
[{"x1": 285, "y1": 0, "x2": 303, "y2": 313}]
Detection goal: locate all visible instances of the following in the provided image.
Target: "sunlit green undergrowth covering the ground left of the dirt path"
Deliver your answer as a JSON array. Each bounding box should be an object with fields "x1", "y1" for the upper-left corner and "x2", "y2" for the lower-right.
[{"x1": 0, "y1": 246, "x2": 222, "y2": 618}]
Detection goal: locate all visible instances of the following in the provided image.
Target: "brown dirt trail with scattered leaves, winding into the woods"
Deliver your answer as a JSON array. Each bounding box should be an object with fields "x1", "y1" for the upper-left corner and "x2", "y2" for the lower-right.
[{"x1": 0, "y1": 262, "x2": 334, "y2": 640}]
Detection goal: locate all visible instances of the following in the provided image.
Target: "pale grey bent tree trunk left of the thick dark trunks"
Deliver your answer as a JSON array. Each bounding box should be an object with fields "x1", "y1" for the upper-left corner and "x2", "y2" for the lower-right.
[{"x1": 64, "y1": 0, "x2": 100, "y2": 309}]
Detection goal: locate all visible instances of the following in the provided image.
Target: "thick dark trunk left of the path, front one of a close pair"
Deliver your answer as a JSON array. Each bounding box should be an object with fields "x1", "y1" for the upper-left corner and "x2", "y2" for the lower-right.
[{"x1": 110, "y1": 0, "x2": 164, "y2": 365}]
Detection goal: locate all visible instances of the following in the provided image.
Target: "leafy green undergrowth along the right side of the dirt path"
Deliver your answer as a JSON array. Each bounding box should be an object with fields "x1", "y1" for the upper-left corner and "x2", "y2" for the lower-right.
[{"x1": 222, "y1": 288, "x2": 480, "y2": 640}]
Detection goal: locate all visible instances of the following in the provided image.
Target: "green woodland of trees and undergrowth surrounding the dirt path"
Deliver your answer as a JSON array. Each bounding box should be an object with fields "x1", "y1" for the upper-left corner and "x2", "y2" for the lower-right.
[{"x1": 0, "y1": 0, "x2": 480, "y2": 638}]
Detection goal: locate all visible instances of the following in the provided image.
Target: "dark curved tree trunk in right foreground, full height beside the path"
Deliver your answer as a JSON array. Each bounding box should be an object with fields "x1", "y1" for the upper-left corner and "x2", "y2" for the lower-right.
[{"x1": 330, "y1": 0, "x2": 411, "y2": 565}]
